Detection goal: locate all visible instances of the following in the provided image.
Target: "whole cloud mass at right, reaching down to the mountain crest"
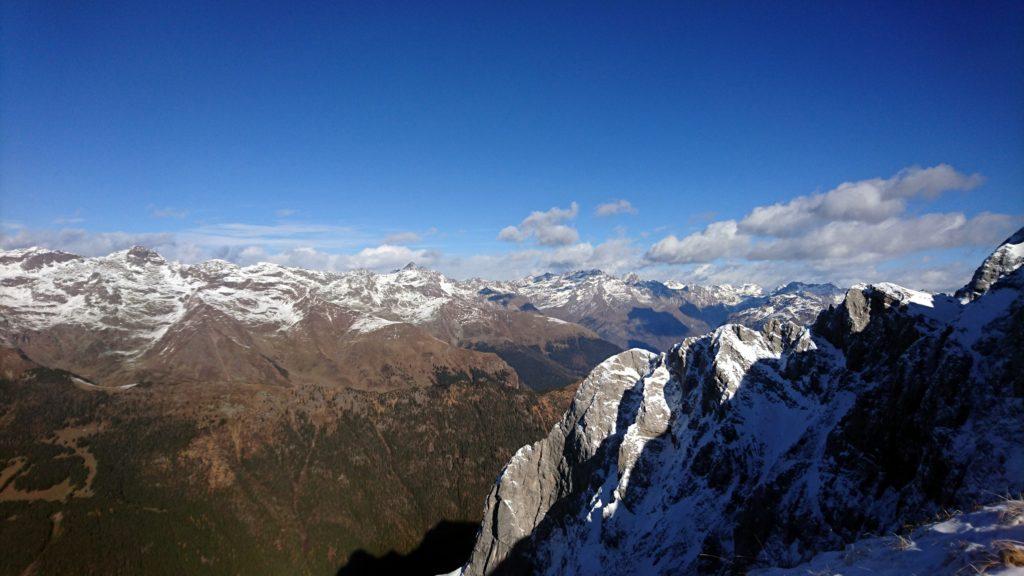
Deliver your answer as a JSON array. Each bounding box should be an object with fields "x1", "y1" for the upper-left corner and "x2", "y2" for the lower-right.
[{"x1": 644, "y1": 164, "x2": 1024, "y2": 290}]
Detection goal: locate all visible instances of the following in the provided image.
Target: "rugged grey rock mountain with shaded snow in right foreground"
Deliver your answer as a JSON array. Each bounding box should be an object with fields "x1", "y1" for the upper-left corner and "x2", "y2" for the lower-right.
[{"x1": 461, "y1": 226, "x2": 1024, "y2": 575}]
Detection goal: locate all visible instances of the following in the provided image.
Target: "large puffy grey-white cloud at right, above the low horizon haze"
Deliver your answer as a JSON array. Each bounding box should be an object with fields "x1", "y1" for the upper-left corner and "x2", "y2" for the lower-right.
[{"x1": 646, "y1": 164, "x2": 1007, "y2": 263}]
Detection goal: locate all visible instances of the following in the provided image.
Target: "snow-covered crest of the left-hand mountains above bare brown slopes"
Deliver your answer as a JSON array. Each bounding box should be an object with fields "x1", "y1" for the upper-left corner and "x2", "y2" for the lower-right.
[{"x1": 0, "y1": 247, "x2": 493, "y2": 355}]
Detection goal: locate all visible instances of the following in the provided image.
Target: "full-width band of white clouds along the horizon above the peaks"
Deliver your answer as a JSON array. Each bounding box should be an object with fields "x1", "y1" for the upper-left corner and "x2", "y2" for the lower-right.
[{"x1": 0, "y1": 164, "x2": 1024, "y2": 290}]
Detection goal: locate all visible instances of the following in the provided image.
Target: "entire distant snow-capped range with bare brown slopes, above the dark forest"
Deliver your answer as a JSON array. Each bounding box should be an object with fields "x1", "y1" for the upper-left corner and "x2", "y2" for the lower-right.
[{"x1": 0, "y1": 247, "x2": 835, "y2": 389}]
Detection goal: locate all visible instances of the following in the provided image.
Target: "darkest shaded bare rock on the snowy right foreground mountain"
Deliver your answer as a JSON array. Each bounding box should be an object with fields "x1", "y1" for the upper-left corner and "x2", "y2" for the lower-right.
[{"x1": 490, "y1": 294, "x2": 1024, "y2": 576}]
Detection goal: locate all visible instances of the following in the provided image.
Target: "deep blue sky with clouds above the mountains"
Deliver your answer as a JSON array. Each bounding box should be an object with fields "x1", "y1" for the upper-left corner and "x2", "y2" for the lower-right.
[{"x1": 0, "y1": 1, "x2": 1024, "y2": 289}]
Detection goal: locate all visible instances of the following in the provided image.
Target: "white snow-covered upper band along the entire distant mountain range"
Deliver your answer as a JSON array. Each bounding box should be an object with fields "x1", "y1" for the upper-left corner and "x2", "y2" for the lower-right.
[{"x1": 0, "y1": 246, "x2": 847, "y2": 358}]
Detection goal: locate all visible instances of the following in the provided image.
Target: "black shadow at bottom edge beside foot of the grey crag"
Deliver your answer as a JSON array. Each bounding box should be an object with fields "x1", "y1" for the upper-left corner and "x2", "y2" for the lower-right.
[{"x1": 338, "y1": 520, "x2": 479, "y2": 576}]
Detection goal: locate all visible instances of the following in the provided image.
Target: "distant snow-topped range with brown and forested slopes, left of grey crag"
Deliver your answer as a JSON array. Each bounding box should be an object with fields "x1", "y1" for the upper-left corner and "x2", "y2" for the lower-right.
[{"x1": 0, "y1": 247, "x2": 840, "y2": 574}]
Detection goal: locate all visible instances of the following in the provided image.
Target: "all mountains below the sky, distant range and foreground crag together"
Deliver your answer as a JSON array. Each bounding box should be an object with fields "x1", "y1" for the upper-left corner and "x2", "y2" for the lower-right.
[{"x1": 0, "y1": 231, "x2": 1024, "y2": 575}]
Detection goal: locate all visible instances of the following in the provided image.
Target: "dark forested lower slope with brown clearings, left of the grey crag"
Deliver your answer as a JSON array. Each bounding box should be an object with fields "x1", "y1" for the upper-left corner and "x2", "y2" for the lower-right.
[{"x1": 0, "y1": 348, "x2": 567, "y2": 575}]
